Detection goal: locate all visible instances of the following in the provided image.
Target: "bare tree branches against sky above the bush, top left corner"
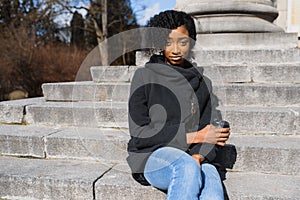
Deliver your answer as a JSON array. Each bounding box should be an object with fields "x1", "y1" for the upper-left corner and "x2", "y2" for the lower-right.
[{"x1": 0, "y1": 0, "x2": 61, "y2": 43}]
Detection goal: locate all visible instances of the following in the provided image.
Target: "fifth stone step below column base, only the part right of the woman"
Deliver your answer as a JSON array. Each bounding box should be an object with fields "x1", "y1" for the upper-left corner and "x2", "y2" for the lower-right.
[{"x1": 228, "y1": 133, "x2": 300, "y2": 175}]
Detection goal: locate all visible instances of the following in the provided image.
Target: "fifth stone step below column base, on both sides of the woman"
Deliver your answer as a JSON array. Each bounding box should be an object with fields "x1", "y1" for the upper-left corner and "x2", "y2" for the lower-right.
[{"x1": 0, "y1": 125, "x2": 300, "y2": 175}]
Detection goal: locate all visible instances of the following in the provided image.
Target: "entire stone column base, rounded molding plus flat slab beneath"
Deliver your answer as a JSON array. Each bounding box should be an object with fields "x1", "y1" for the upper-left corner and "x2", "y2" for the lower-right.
[{"x1": 175, "y1": 0, "x2": 298, "y2": 50}]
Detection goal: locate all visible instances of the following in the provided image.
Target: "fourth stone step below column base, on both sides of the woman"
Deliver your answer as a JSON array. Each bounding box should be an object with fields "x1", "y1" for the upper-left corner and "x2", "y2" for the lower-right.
[{"x1": 0, "y1": 99, "x2": 300, "y2": 134}]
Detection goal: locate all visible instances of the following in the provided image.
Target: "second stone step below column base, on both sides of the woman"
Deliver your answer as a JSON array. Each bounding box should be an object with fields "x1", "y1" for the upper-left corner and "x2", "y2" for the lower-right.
[{"x1": 91, "y1": 63, "x2": 300, "y2": 85}]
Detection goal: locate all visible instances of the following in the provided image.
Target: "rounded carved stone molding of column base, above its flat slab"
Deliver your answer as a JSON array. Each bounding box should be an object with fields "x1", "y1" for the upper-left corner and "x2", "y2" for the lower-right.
[{"x1": 175, "y1": 0, "x2": 283, "y2": 33}]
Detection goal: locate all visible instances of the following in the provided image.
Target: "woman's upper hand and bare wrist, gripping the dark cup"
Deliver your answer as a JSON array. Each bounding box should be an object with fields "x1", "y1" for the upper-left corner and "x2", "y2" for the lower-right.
[{"x1": 187, "y1": 125, "x2": 230, "y2": 146}]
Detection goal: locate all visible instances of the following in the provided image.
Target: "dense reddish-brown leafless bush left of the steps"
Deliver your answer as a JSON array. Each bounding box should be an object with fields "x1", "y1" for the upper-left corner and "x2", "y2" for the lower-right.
[{"x1": 0, "y1": 24, "x2": 87, "y2": 100}]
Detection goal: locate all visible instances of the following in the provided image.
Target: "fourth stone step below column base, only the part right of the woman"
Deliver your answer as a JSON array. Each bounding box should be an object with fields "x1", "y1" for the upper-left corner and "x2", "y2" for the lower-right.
[{"x1": 220, "y1": 106, "x2": 300, "y2": 135}]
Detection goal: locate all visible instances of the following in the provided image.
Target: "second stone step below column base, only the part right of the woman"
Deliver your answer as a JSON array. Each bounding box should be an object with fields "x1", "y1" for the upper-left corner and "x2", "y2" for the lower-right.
[{"x1": 203, "y1": 62, "x2": 300, "y2": 85}]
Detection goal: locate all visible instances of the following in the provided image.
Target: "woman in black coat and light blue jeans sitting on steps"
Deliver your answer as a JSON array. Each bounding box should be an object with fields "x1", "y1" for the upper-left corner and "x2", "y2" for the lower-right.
[{"x1": 127, "y1": 11, "x2": 230, "y2": 200}]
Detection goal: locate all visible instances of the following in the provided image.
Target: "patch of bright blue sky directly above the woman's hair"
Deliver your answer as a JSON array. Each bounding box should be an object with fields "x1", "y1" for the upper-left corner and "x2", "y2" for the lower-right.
[{"x1": 131, "y1": 0, "x2": 176, "y2": 25}]
